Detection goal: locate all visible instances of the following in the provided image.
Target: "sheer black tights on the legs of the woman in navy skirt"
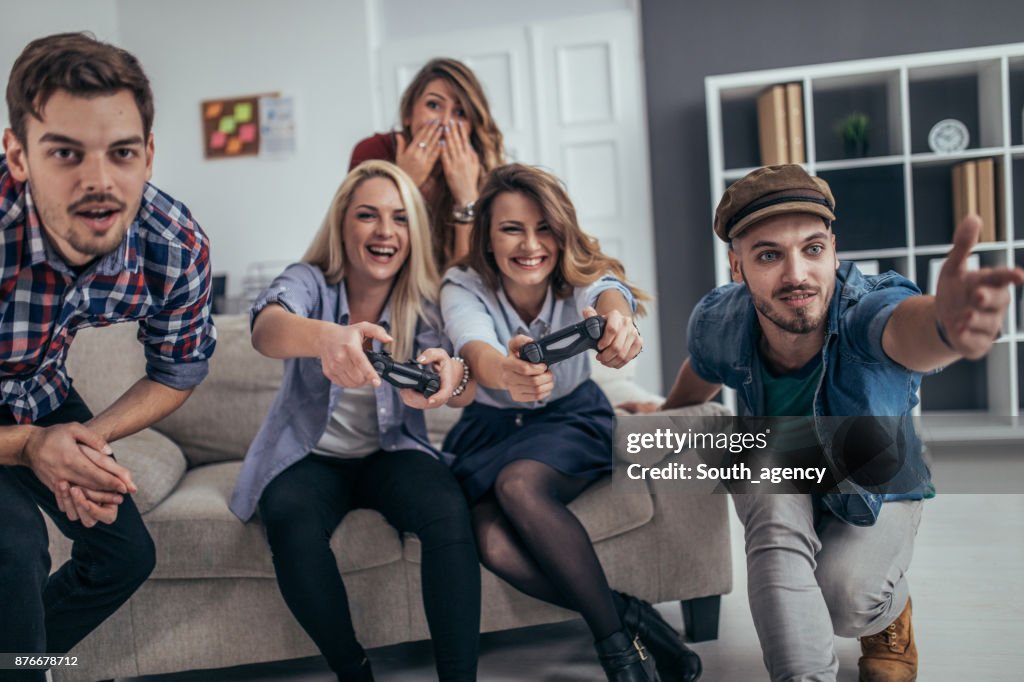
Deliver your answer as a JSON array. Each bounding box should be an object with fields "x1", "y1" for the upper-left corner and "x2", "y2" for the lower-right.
[{"x1": 473, "y1": 460, "x2": 623, "y2": 641}]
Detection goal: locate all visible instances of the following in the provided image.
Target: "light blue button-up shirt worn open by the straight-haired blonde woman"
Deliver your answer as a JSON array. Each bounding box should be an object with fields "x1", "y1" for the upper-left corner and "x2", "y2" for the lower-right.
[{"x1": 230, "y1": 263, "x2": 451, "y2": 521}]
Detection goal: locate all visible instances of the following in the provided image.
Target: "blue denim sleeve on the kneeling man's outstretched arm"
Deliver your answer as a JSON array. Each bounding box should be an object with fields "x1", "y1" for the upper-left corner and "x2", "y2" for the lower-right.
[{"x1": 840, "y1": 271, "x2": 921, "y2": 365}]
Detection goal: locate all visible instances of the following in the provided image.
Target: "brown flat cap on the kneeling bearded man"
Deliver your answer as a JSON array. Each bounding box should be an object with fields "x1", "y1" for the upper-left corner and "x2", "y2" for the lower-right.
[{"x1": 715, "y1": 164, "x2": 836, "y2": 242}]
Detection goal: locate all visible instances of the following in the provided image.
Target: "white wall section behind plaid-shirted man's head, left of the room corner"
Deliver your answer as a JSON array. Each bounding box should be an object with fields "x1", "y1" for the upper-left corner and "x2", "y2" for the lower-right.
[{"x1": 0, "y1": 0, "x2": 118, "y2": 128}]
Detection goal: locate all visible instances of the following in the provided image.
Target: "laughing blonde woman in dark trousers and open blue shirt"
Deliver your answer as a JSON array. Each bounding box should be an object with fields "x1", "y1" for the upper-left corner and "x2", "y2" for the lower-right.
[{"x1": 231, "y1": 161, "x2": 480, "y2": 682}]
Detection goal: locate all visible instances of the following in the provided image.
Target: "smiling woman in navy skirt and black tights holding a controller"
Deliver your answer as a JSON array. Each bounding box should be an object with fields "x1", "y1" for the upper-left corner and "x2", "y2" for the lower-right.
[{"x1": 441, "y1": 164, "x2": 699, "y2": 682}]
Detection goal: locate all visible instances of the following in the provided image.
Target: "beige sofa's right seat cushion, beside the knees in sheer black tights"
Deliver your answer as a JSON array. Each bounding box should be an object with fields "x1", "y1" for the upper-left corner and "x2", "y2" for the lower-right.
[{"x1": 404, "y1": 476, "x2": 654, "y2": 563}]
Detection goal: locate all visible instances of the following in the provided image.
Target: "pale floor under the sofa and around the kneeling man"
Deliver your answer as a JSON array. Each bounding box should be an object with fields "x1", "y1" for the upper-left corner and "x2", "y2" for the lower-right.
[{"x1": 122, "y1": 452, "x2": 1024, "y2": 682}]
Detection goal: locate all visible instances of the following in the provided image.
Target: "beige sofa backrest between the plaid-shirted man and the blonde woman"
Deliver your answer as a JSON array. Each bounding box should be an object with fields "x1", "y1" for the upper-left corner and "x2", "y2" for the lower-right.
[{"x1": 68, "y1": 315, "x2": 284, "y2": 467}]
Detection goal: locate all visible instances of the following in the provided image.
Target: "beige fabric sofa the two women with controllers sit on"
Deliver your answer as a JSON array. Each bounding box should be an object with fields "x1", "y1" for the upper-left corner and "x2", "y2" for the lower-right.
[{"x1": 47, "y1": 315, "x2": 731, "y2": 681}]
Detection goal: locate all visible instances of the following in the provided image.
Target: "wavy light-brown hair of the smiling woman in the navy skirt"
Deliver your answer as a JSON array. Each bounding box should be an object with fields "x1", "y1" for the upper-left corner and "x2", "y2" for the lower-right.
[{"x1": 462, "y1": 164, "x2": 651, "y2": 316}]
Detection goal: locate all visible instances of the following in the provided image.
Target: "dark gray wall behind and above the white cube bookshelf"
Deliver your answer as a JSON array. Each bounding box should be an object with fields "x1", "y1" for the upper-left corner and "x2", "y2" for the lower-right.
[{"x1": 641, "y1": 0, "x2": 1024, "y2": 390}]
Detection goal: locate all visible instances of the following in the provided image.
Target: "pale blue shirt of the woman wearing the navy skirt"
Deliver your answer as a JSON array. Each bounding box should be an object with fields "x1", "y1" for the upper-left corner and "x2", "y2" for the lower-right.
[{"x1": 441, "y1": 266, "x2": 637, "y2": 409}]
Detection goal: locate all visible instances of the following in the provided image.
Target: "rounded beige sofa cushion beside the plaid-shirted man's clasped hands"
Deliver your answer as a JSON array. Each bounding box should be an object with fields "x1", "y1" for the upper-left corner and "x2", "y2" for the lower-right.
[{"x1": 113, "y1": 429, "x2": 187, "y2": 514}]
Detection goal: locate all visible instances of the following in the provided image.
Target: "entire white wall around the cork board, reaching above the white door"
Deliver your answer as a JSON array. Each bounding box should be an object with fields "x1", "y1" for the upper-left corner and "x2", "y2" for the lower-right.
[{"x1": 0, "y1": 0, "x2": 651, "y2": 311}]
